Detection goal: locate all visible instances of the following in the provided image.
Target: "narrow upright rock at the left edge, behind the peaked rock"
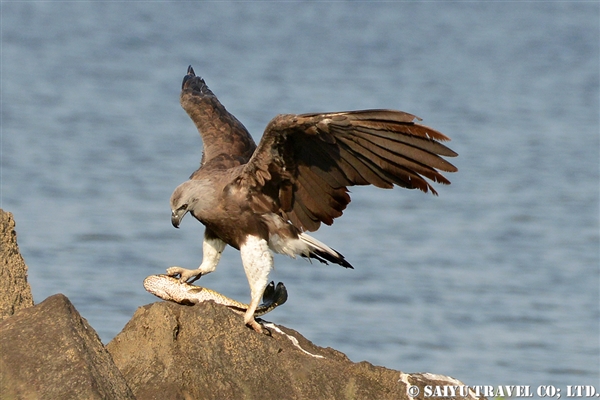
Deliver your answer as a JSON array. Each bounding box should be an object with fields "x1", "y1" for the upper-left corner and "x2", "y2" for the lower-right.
[{"x1": 0, "y1": 208, "x2": 33, "y2": 320}]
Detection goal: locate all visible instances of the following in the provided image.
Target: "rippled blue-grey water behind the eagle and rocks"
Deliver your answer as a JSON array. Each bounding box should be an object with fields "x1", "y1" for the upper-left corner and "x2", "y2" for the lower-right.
[{"x1": 0, "y1": 2, "x2": 600, "y2": 395}]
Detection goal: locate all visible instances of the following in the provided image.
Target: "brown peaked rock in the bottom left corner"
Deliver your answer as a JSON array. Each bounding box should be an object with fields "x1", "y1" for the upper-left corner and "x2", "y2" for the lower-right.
[{"x1": 0, "y1": 294, "x2": 135, "y2": 399}]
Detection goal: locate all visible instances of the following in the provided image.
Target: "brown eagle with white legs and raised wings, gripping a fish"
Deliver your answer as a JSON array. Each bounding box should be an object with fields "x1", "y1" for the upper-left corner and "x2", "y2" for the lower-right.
[{"x1": 167, "y1": 66, "x2": 457, "y2": 332}]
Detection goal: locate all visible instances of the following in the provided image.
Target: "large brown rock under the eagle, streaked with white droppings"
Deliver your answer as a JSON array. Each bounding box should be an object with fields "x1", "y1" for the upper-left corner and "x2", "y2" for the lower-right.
[{"x1": 107, "y1": 302, "x2": 482, "y2": 400}]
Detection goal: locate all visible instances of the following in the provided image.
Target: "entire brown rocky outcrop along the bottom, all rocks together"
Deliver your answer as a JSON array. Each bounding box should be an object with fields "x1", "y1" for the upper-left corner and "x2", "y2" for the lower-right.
[{"x1": 0, "y1": 210, "x2": 482, "y2": 400}]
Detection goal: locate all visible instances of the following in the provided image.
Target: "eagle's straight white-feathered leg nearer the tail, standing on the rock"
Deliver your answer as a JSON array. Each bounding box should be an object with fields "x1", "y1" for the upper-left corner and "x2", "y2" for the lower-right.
[{"x1": 240, "y1": 236, "x2": 273, "y2": 333}]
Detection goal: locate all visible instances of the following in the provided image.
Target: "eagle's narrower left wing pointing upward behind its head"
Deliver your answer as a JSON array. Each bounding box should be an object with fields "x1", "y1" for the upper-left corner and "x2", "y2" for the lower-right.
[{"x1": 180, "y1": 65, "x2": 256, "y2": 179}]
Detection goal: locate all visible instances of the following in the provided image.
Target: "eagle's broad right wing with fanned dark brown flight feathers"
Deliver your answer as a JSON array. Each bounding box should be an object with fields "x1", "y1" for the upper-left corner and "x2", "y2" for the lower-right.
[{"x1": 238, "y1": 110, "x2": 457, "y2": 231}]
